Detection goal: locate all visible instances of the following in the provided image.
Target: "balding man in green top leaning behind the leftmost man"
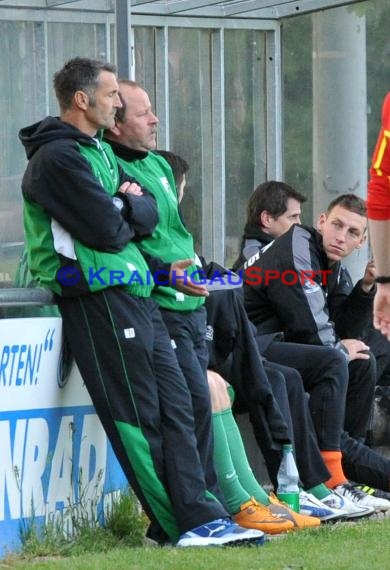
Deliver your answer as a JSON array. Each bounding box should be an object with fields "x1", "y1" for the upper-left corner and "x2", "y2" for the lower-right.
[{"x1": 105, "y1": 80, "x2": 219, "y2": 510}]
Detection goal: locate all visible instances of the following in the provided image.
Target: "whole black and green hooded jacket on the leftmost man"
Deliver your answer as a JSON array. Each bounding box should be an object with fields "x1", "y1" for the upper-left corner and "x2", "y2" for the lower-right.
[{"x1": 19, "y1": 113, "x2": 166, "y2": 296}]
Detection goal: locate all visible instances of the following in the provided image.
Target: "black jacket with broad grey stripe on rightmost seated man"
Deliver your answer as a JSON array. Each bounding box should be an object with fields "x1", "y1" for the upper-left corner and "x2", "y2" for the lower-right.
[{"x1": 244, "y1": 224, "x2": 373, "y2": 353}]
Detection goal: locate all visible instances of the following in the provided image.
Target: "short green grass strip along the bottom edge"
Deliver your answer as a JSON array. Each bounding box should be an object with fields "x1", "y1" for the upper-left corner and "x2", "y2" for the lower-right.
[{"x1": 0, "y1": 518, "x2": 390, "y2": 570}]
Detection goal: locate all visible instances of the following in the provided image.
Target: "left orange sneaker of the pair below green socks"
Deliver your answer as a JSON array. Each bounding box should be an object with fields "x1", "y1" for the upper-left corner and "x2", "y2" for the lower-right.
[{"x1": 233, "y1": 497, "x2": 295, "y2": 534}]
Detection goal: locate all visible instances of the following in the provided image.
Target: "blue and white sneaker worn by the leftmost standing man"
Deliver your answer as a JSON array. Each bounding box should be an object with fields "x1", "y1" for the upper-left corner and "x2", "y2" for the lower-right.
[{"x1": 176, "y1": 519, "x2": 265, "y2": 546}]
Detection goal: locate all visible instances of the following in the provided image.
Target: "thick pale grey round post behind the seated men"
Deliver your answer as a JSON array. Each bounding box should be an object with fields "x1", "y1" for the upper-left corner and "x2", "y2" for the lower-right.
[{"x1": 313, "y1": 4, "x2": 367, "y2": 280}]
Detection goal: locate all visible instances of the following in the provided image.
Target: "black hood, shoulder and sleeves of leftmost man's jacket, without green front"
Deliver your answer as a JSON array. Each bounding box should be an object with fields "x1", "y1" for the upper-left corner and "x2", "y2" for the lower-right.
[{"x1": 19, "y1": 117, "x2": 157, "y2": 252}]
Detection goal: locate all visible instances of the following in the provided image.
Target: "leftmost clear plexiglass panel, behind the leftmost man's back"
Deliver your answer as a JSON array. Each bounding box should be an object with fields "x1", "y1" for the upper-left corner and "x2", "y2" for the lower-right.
[{"x1": 0, "y1": 21, "x2": 46, "y2": 286}]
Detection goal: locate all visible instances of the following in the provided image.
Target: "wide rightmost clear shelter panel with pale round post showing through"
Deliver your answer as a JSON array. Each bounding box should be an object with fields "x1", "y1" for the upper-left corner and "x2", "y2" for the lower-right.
[{"x1": 282, "y1": 0, "x2": 390, "y2": 224}]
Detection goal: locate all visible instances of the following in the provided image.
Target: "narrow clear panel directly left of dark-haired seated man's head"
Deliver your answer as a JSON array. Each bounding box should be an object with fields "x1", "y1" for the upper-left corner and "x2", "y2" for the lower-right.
[{"x1": 224, "y1": 30, "x2": 267, "y2": 266}]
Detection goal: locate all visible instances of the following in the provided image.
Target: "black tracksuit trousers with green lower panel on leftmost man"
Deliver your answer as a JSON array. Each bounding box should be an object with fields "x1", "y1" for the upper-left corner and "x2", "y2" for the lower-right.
[{"x1": 58, "y1": 287, "x2": 228, "y2": 541}]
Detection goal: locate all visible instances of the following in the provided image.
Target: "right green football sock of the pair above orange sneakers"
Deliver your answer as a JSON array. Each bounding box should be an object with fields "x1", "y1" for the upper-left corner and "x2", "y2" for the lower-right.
[{"x1": 221, "y1": 408, "x2": 269, "y2": 505}]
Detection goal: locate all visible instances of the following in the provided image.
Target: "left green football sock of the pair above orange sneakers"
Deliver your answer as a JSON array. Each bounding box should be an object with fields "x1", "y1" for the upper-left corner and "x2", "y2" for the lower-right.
[{"x1": 213, "y1": 412, "x2": 250, "y2": 514}]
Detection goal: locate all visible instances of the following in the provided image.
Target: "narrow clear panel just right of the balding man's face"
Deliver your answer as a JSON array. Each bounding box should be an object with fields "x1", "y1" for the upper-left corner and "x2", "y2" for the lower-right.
[{"x1": 168, "y1": 28, "x2": 213, "y2": 253}]
